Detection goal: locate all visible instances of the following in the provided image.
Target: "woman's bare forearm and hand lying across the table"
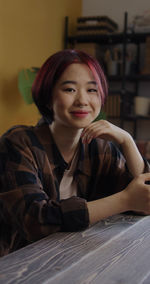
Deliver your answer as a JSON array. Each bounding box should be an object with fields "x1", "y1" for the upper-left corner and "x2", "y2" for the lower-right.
[{"x1": 87, "y1": 173, "x2": 150, "y2": 224}]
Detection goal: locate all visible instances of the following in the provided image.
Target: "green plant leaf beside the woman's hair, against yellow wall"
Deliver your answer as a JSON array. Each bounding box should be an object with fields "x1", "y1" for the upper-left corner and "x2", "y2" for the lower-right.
[{"x1": 18, "y1": 67, "x2": 39, "y2": 104}]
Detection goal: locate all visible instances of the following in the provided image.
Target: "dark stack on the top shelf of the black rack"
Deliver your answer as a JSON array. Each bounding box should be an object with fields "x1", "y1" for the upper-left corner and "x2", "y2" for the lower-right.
[{"x1": 77, "y1": 16, "x2": 118, "y2": 35}]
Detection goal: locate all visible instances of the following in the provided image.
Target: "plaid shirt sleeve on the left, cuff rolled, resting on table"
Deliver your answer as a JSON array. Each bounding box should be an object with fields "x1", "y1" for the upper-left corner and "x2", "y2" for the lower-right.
[{"x1": 0, "y1": 130, "x2": 89, "y2": 241}]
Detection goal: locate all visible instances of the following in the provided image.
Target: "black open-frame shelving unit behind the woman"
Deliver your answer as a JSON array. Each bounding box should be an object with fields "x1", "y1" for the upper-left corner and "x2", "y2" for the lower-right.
[{"x1": 64, "y1": 13, "x2": 150, "y2": 139}]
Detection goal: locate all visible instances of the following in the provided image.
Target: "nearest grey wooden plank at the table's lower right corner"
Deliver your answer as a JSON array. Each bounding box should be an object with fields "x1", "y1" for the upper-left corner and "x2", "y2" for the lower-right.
[{"x1": 51, "y1": 217, "x2": 150, "y2": 284}]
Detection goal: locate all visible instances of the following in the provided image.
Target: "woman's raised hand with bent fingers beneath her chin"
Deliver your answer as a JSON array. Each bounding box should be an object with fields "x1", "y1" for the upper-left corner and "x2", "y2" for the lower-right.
[{"x1": 81, "y1": 120, "x2": 131, "y2": 145}]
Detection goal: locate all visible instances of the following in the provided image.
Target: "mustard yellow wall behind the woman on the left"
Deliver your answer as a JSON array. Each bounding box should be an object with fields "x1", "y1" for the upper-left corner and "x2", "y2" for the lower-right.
[{"x1": 0, "y1": 0, "x2": 82, "y2": 135}]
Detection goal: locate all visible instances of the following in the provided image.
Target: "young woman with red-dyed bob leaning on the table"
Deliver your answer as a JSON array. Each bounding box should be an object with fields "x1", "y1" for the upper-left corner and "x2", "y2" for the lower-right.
[{"x1": 0, "y1": 50, "x2": 150, "y2": 255}]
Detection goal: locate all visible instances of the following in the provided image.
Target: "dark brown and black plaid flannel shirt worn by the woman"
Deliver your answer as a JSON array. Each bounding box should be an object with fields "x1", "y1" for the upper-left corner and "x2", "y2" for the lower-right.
[{"x1": 0, "y1": 119, "x2": 150, "y2": 255}]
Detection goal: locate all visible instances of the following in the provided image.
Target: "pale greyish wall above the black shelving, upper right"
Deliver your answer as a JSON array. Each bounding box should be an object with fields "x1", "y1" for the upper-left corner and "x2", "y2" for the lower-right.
[{"x1": 82, "y1": 0, "x2": 150, "y2": 30}]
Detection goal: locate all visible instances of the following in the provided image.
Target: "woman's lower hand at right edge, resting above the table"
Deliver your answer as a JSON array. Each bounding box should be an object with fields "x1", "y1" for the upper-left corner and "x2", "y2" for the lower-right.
[{"x1": 124, "y1": 173, "x2": 150, "y2": 215}]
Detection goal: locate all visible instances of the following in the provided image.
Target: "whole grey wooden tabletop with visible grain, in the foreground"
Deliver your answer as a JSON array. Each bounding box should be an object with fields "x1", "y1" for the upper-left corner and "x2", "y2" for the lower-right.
[{"x1": 0, "y1": 214, "x2": 150, "y2": 284}]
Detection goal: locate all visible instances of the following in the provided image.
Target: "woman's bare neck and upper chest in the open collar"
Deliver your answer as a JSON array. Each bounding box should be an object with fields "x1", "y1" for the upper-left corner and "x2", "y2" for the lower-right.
[{"x1": 50, "y1": 123, "x2": 82, "y2": 163}]
